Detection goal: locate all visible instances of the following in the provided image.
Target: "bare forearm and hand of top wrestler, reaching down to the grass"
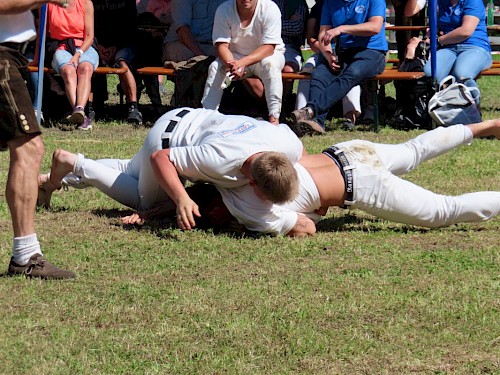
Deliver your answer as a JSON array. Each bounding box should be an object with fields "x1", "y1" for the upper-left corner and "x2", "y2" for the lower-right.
[{"x1": 151, "y1": 148, "x2": 201, "y2": 230}]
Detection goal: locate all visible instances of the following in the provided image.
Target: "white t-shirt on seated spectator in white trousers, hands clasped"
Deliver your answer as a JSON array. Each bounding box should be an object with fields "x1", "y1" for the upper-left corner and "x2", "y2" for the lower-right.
[{"x1": 212, "y1": 0, "x2": 285, "y2": 56}]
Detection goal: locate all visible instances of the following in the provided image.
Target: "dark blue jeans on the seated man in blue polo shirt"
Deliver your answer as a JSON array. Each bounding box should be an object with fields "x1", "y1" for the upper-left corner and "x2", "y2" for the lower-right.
[{"x1": 307, "y1": 49, "x2": 385, "y2": 127}]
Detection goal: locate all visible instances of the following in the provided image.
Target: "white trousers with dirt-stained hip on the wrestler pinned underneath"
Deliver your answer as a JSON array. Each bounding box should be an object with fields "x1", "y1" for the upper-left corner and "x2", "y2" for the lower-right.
[{"x1": 336, "y1": 125, "x2": 500, "y2": 228}]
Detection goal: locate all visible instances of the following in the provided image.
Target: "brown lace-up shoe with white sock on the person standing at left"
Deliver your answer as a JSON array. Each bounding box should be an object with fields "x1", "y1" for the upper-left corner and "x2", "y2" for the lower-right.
[{"x1": 7, "y1": 254, "x2": 76, "y2": 280}]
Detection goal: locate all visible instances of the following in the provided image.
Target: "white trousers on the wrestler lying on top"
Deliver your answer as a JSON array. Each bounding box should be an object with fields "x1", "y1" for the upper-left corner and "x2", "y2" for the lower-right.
[{"x1": 64, "y1": 111, "x2": 182, "y2": 210}]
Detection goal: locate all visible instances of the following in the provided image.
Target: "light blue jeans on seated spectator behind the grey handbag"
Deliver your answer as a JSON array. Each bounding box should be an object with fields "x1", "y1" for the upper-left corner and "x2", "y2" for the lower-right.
[{"x1": 424, "y1": 44, "x2": 492, "y2": 87}]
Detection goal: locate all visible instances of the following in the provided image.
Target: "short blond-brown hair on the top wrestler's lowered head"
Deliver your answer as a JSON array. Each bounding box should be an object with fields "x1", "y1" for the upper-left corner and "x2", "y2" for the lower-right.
[{"x1": 251, "y1": 152, "x2": 299, "y2": 204}]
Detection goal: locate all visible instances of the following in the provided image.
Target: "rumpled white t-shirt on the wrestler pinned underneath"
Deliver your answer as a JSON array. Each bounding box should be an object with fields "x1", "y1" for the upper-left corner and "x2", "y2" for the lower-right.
[{"x1": 217, "y1": 164, "x2": 321, "y2": 234}]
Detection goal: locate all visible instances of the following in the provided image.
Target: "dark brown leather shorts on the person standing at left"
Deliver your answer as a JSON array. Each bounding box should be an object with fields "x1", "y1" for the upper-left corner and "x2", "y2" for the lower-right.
[{"x1": 0, "y1": 45, "x2": 41, "y2": 146}]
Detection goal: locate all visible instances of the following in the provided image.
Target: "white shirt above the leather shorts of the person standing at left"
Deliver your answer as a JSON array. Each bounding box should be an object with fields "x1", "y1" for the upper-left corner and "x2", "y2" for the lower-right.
[{"x1": 0, "y1": 11, "x2": 36, "y2": 43}]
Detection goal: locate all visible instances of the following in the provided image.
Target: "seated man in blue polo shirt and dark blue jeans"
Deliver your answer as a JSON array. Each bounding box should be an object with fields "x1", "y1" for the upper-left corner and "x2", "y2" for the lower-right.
[{"x1": 292, "y1": 0, "x2": 388, "y2": 134}]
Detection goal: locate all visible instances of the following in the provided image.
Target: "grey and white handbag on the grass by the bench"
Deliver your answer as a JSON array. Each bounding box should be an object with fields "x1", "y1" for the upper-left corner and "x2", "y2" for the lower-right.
[{"x1": 429, "y1": 76, "x2": 482, "y2": 126}]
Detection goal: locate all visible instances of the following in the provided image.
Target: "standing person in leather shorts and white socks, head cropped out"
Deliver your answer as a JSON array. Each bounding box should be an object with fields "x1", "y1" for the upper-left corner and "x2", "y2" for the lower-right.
[{"x1": 0, "y1": 0, "x2": 76, "y2": 279}]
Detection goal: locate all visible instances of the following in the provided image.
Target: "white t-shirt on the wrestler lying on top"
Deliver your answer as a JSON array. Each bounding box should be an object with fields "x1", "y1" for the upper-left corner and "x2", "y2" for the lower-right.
[{"x1": 168, "y1": 108, "x2": 303, "y2": 188}]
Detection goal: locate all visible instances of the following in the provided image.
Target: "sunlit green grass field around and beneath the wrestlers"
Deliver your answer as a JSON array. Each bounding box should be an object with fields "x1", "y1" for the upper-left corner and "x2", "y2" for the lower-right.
[{"x1": 0, "y1": 77, "x2": 500, "y2": 374}]
